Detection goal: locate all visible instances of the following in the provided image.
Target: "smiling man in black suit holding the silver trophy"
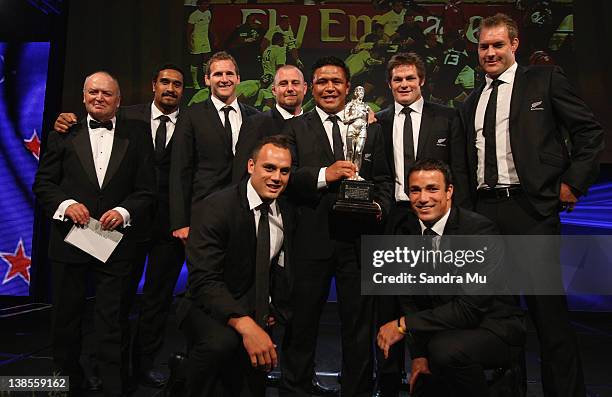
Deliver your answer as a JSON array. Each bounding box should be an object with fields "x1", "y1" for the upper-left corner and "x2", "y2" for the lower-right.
[{"x1": 281, "y1": 57, "x2": 393, "y2": 396}]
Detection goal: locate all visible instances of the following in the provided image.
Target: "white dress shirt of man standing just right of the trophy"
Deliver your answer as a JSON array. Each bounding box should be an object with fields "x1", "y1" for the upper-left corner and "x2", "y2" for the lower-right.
[{"x1": 393, "y1": 97, "x2": 425, "y2": 201}]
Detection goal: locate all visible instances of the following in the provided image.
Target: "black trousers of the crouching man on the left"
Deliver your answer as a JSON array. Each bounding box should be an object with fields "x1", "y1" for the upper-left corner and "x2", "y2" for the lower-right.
[{"x1": 181, "y1": 305, "x2": 266, "y2": 397}]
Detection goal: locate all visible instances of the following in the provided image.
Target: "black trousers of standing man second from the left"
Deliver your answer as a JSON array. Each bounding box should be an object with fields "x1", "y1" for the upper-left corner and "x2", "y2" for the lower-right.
[{"x1": 133, "y1": 231, "x2": 185, "y2": 374}]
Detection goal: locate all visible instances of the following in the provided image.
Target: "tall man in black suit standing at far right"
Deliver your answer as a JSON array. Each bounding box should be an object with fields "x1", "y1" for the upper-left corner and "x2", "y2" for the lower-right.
[{"x1": 451, "y1": 14, "x2": 604, "y2": 396}]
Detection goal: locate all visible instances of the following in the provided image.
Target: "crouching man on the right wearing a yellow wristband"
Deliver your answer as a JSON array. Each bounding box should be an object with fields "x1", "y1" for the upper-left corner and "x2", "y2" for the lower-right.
[{"x1": 377, "y1": 160, "x2": 524, "y2": 397}]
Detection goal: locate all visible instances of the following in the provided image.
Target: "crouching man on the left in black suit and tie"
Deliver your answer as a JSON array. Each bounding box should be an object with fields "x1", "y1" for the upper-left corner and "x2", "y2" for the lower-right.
[{"x1": 177, "y1": 136, "x2": 292, "y2": 396}]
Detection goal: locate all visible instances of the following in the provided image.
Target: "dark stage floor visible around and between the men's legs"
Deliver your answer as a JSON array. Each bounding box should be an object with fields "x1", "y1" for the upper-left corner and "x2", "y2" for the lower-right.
[{"x1": 0, "y1": 302, "x2": 612, "y2": 397}]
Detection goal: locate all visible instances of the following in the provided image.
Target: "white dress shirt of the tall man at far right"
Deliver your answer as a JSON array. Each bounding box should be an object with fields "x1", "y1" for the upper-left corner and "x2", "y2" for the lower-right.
[{"x1": 474, "y1": 62, "x2": 520, "y2": 189}]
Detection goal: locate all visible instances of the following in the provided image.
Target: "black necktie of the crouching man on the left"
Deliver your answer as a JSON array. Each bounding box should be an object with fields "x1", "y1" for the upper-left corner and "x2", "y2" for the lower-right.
[{"x1": 255, "y1": 202, "x2": 270, "y2": 328}]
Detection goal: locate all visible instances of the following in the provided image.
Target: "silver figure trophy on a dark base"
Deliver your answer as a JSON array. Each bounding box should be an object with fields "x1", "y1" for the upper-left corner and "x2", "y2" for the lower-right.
[{"x1": 334, "y1": 86, "x2": 379, "y2": 215}]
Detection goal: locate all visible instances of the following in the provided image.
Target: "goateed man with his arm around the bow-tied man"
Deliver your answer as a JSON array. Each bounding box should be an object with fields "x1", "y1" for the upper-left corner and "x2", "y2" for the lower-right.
[{"x1": 54, "y1": 63, "x2": 185, "y2": 391}]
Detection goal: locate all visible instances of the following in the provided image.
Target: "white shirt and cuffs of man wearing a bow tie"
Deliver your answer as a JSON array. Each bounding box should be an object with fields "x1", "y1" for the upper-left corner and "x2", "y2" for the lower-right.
[{"x1": 53, "y1": 115, "x2": 130, "y2": 227}]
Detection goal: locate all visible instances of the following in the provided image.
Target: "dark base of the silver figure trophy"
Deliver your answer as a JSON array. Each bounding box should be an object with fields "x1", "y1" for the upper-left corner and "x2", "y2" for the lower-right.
[{"x1": 333, "y1": 179, "x2": 380, "y2": 214}]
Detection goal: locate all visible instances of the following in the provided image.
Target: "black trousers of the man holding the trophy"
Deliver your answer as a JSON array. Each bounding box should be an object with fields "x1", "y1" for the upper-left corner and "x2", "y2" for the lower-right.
[{"x1": 279, "y1": 242, "x2": 374, "y2": 397}]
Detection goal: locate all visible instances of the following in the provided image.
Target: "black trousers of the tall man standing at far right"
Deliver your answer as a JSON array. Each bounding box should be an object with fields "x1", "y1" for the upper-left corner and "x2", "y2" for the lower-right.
[{"x1": 476, "y1": 190, "x2": 586, "y2": 397}]
